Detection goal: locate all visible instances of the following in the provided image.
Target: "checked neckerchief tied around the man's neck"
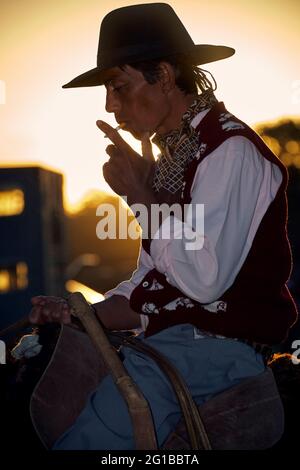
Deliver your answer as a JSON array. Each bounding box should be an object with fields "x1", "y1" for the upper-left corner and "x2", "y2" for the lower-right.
[{"x1": 152, "y1": 90, "x2": 218, "y2": 194}]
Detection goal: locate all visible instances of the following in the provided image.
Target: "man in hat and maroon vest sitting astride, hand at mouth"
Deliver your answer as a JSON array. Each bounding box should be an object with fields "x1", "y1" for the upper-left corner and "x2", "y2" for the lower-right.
[{"x1": 31, "y1": 3, "x2": 296, "y2": 449}]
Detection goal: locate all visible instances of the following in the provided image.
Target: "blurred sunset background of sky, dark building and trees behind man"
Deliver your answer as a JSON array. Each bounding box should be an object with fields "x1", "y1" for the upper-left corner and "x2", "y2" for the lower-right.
[{"x1": 0, "y1": 0, "x2": 300, "y2": 342}]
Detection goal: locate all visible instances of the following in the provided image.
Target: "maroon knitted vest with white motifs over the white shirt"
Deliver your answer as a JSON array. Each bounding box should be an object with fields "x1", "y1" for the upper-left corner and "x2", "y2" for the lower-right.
[{"x1": 130, "y1": 102, "x2": 297, "y2": 344}]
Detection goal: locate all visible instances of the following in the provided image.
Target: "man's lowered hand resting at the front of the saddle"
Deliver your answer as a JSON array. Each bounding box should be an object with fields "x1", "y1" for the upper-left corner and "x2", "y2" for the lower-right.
[{"x1": 29, "y1": 295, "x2": 71, "y2": 325}]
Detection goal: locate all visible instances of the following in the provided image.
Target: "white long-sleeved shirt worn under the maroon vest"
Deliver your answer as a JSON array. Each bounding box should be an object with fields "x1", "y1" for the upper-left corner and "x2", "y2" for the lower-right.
[{"x1": 105, "y1": 110, "x2": 282, "y2": 329}]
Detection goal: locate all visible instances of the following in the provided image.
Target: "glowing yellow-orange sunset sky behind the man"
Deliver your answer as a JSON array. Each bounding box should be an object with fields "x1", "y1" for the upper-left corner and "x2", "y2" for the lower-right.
[{"x1": 0, "y1": 0, "x2": 300, "y2": 209}]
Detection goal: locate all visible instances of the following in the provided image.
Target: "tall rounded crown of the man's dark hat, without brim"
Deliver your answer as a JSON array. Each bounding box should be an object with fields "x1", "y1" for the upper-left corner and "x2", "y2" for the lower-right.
[{"x1": 97, "y1": 3, "x2": 194, "y2": 66}]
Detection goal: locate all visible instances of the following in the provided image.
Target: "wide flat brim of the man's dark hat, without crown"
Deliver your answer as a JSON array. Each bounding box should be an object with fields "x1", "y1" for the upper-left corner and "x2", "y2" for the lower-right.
[{"x1": 62, "y1": 44, "x2": 235, "y2": 88}]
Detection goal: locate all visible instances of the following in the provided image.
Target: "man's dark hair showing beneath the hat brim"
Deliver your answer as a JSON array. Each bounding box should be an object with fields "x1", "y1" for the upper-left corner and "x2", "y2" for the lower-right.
[{"x1": 125, "y1": 56, "x2": 217, "y2": 94}]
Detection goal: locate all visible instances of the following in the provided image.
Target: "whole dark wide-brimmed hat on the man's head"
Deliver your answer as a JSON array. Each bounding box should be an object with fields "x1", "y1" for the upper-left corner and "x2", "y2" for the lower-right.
[{"x1": 63, "y1": 3, "x2": 235, "y2": 88}]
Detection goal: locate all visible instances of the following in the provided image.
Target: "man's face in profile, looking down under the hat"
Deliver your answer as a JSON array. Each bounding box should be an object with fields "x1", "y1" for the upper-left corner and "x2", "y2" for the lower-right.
[{"x1": 104, "y1": 65, "x2": 169, "y2": 139}]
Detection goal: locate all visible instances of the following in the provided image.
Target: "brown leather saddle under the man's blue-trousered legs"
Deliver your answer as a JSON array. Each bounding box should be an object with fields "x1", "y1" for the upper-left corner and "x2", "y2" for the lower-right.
[{"x1": 30, "y1": 326, "x2": 284, "y2": 450}]
